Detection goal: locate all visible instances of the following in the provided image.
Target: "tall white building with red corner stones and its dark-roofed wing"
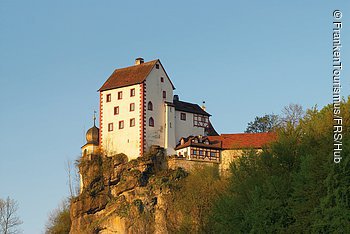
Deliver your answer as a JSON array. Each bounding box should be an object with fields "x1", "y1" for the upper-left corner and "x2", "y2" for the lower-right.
[{"x1": 83, "y1": 58, "x2": 217, "y2": 160}]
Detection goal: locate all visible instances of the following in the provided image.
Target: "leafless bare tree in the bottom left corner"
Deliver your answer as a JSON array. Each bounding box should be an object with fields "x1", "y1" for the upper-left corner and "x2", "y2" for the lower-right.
[{"x1": 0, "y1": 197, "x2": 22, "y2": 234}]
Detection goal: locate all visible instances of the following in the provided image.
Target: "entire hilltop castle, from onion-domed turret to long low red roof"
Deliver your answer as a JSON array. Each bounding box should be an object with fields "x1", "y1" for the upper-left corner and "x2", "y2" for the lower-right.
[{"x1": 82, "y1": 58, "x2": 276, "y2": 172}]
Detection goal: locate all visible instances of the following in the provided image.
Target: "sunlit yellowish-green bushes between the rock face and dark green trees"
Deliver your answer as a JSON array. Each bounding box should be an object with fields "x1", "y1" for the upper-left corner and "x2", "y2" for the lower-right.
[{"x1": 167, "y1": 166, "x2": 225, "y2": 233}]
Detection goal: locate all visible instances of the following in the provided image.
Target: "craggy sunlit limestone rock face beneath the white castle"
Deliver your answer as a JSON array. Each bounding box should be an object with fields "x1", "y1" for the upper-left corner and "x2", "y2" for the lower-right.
[{"x1": 70, "y1": 149, "x2": 186, "y2": 234}]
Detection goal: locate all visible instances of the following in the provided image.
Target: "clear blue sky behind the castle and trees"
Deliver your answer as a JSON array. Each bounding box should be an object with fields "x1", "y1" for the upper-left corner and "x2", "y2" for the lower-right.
[{"x1": 0, "y1": 0, "x2": 350, "y2": 234}]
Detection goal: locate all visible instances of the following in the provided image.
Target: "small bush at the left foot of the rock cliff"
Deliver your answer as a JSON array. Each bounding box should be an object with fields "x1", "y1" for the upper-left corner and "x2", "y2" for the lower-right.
[{"x1": 45, "y1": 200, "x2": 71, "y2": 234}]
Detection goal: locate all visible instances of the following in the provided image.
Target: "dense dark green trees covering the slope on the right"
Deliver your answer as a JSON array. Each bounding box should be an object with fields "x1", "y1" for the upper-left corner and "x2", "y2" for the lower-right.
[{"x1": 210, "y1": 98, "x2": 350, "y2": 233}]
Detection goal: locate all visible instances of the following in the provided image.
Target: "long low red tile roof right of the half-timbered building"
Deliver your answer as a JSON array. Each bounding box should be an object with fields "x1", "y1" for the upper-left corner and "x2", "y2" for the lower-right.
[{"x1": 208, "y1": 132, "x2": 277, "y2": 149}]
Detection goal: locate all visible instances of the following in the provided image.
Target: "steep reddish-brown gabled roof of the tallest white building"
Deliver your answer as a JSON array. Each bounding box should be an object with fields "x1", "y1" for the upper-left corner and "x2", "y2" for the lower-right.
[{"x1": 98, "y1": 59, "x2": 175, "y2": 91}]
